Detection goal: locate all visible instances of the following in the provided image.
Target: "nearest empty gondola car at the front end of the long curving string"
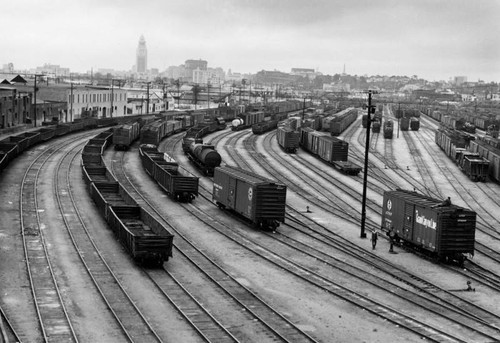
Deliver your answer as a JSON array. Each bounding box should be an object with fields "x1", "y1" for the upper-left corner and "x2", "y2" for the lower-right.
[{"x1": 108, "y1": 206, "x2": 174, "y2": 265}]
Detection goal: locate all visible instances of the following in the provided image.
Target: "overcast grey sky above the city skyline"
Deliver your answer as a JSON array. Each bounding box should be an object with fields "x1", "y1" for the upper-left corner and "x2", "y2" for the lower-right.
[{"x1": 0, "y1": 0, "x2": 500, "y2": 82}]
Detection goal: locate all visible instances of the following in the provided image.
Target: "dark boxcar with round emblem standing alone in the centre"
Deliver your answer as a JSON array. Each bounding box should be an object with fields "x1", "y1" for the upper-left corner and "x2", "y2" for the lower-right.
[{"x1": 213, "y1": 166, "x2": 286, "y2": 230}]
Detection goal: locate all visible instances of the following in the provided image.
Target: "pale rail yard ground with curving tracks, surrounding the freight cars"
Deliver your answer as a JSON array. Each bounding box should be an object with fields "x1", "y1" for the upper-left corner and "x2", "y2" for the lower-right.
[{"x1": 0, "y1": 107, "x2": 500, "y2": 342}]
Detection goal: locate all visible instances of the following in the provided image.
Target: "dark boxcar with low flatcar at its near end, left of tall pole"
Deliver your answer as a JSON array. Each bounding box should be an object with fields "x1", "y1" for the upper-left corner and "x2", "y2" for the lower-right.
[{"x1": 299, "y1": 128, "x2": 362, "y2": 175}]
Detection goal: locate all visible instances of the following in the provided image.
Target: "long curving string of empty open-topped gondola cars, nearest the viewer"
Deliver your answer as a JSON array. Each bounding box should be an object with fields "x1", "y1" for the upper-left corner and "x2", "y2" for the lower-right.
[{"x1": 82, "y1": 129, "x2": 173, "y2": 266}]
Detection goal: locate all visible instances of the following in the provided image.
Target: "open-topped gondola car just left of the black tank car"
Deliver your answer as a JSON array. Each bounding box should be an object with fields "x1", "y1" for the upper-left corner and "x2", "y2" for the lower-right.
[{"x1": 139, "y1": 145, "x2": 199, "y2": 202}]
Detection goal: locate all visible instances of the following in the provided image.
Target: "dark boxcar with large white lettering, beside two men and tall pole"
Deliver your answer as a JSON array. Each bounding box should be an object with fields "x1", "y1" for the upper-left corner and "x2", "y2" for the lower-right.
[{"x1": 382, "y1": 189, "x2": 476, "y2": 264}]
